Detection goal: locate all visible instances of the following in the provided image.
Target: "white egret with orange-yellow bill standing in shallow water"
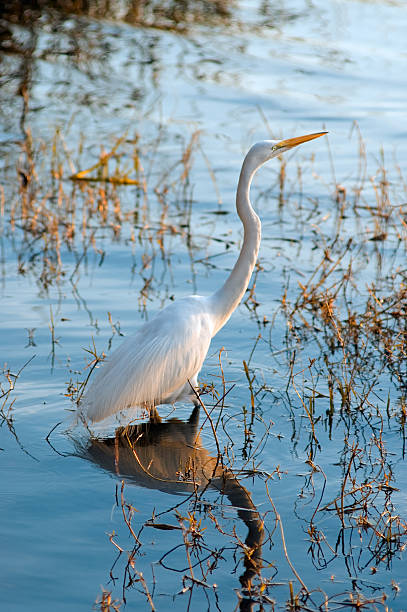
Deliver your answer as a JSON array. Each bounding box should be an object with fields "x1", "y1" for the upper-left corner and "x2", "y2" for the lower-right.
[{"x1": 82, "y1": 132, "x2": 326, "y2": 422}]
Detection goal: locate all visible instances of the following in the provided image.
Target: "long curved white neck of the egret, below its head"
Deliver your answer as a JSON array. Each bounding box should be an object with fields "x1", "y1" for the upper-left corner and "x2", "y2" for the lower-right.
[{"x1": 211, "y1": 156, "x2": 261, "y2": 335}]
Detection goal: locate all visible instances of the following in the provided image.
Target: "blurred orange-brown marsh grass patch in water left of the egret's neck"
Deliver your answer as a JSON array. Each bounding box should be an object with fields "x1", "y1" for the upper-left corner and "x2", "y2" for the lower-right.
[{"x1": 2, "y1": 125, "x2": 207, "y2": 296}]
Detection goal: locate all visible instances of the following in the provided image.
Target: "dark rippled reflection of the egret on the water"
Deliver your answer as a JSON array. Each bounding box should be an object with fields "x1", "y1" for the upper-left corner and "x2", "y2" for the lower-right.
[{"x1": 81, "y1": 407, "x2": 264, "y2": 610}]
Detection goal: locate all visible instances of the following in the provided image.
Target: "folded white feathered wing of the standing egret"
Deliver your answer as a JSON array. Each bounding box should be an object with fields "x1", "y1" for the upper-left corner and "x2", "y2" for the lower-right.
[{"x1": 82, "y1": 296, "x2": 213, "y2": 421}]
